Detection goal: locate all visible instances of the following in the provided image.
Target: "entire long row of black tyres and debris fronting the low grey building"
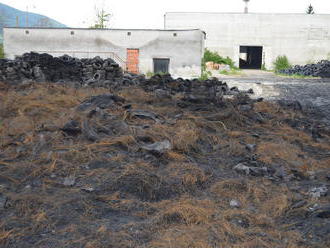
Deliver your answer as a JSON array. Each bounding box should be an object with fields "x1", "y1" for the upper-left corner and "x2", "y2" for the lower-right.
[{"x1": 0, "y1": 52, "x2": 253, "y2": 97}]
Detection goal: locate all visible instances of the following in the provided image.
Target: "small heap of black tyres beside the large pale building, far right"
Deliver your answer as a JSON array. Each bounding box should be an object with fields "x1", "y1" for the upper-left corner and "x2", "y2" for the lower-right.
[{"x1": 280, "y1": 60, "x2": 330, "y2": 78}]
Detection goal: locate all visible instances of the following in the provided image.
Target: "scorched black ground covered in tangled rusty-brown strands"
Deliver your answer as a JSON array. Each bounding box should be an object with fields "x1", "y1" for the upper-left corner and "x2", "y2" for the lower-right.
[{"x1": 0, "y1": 83, "x2": 330, "y2": 248}]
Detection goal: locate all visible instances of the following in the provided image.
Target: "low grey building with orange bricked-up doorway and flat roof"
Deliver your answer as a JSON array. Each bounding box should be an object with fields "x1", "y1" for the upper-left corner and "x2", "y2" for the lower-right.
[{"x1": 4, "y1": 28, "x2": 205, "y2": 77}]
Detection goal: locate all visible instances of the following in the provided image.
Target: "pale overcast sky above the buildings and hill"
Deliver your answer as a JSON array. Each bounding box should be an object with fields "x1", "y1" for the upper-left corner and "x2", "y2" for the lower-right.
[{"x1": 0, "y1": 0, "x2": 330, "y2": 28}]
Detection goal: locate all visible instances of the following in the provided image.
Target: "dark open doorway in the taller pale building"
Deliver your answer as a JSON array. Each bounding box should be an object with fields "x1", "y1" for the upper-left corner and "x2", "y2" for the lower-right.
[{"x1": 239, "y1": 46, "x2": 262, "y2": 69}]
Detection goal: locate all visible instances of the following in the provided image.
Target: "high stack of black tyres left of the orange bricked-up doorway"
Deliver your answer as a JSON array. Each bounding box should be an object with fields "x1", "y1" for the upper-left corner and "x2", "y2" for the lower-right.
[{"x1": 0, "y1": 52, "x2": 123, "y2": 85}]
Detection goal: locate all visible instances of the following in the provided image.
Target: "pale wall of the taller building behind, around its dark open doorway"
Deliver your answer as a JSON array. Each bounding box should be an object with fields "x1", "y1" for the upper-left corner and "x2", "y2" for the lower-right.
[{"x1": 165, "y1": 13, "x2": 330, "y2": 68}]
